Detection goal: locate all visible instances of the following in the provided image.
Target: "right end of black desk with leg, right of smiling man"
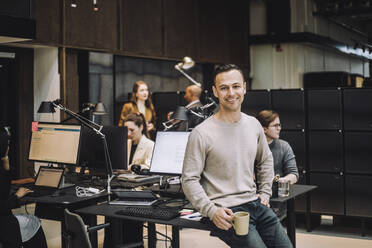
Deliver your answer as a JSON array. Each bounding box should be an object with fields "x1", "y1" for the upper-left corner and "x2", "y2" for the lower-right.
[{"x1": 270, "y1": 184, "x2": 317, "y2": 248}]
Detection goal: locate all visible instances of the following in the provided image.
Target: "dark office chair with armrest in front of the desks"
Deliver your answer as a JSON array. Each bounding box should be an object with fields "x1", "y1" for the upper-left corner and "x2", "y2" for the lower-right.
[{"x1": 63, "y1": 209, "x2": 143, "y2": 248}]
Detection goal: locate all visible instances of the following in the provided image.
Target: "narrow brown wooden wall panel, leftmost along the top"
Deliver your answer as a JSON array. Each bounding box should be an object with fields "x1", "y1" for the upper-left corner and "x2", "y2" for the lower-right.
[{"x1": 35, "y1": 0, "x2": 62, "y2": 45}]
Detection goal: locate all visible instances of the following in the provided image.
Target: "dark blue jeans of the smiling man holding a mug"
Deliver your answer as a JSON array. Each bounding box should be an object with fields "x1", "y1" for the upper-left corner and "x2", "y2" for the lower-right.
[{"x1": 208, "y1": 199, "x2": 292, "y2": 248}]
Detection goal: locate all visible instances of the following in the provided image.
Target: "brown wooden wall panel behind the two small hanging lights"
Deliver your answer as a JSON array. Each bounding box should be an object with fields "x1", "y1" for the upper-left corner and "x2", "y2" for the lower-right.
[{"x1": 63, "y1": 0, "x2": 118, "y2": 51}]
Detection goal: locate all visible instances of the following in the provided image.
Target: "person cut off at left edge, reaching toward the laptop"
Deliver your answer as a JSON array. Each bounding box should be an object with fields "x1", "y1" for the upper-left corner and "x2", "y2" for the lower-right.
[{"x1": 0, "y1": 132, "x2": 47, "y2": 248}]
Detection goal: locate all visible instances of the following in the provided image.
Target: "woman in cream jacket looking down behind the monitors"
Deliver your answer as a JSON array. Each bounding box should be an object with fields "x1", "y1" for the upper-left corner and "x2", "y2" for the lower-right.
[{"x1": 124, "y1": 113, "x2": 154, "y2": 170}]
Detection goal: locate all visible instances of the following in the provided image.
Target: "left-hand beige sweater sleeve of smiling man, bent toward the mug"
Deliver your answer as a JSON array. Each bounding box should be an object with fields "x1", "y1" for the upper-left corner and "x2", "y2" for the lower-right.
[{"x1": 182, "y1": 130, "x2": 217, "y2": 219}]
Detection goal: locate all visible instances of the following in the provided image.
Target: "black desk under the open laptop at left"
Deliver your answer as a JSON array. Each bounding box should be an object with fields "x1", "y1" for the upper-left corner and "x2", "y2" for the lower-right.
[{"x1": 22, "y1": 187, "x2": 107, "y2": 247}]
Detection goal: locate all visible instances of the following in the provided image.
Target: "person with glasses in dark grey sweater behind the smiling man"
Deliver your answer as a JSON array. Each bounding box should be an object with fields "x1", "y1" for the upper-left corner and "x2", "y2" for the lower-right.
[{"x1": 257, "y1": 110, "x2": 298, "y2": 184}]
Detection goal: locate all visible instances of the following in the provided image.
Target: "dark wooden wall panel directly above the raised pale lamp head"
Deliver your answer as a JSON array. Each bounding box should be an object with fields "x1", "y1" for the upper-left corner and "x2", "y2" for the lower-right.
[{"x1": 164, "y1": 0, "x2": 199, "y2": 59}]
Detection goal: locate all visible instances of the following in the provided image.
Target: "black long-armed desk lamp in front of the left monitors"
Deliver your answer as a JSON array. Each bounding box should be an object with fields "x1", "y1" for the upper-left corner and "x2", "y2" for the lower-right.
[{"x1": 38, "y1": 99, "x2": 114, "y2": 202}]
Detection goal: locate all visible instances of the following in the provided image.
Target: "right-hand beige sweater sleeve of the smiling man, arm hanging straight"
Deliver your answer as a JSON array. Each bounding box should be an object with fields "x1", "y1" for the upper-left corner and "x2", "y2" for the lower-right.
[{"x1": 256, "y1": 125, "x2": 274, "y2": 200}]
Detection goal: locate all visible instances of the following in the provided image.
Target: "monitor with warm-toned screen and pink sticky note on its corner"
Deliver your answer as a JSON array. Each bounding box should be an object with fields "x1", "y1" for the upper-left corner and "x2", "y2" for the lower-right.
[{"x1": 28, "y1": 123, "x2": 81, "y2": 165}]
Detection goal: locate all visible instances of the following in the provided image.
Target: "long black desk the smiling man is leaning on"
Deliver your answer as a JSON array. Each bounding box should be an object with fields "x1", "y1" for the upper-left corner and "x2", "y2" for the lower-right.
[{"x1": 76, "y1": 185, "x2": 317, "y2": 248}]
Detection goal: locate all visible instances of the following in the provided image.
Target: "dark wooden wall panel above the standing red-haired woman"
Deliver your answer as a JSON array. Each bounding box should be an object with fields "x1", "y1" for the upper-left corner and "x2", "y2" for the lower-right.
[{"x1": 120, "y1": 0, "x2": 163, "y2": 57}]
